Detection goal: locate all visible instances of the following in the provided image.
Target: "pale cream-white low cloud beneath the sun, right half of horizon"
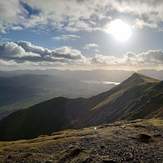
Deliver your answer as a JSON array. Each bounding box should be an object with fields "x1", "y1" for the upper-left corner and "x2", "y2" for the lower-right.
[{"x1": 90, "y1": 50, "x2": 163, "y2": 69}]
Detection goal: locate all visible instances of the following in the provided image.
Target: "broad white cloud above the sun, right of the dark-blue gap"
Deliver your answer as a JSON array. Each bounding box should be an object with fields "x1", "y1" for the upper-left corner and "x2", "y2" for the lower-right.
[{"x1": 19, "y1": 0, "x2": 163, "y2": 31}]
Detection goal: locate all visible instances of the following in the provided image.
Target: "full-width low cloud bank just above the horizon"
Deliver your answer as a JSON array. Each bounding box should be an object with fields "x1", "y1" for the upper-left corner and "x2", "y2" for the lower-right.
[{"x1": 0, "y1": 41, "x2": 163, "y2": 70}]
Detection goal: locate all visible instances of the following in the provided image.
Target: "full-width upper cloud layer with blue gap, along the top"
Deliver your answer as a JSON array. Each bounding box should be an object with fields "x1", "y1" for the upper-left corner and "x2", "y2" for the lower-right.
[{"x1": 0, "y1": 0, "x2": 163, "y2": 32}]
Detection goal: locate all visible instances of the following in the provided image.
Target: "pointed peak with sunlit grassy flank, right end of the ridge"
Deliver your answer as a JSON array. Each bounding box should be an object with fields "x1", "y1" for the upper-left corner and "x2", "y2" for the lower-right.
[{"x1": 88, "y1": 73, "x2": 163, "y2": 124}]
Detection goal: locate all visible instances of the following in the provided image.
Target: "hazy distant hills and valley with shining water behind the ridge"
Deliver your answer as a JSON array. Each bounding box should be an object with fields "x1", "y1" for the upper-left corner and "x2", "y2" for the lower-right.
[{"x1": 0, "y1": 69, "x2": 163, "y2": 119}]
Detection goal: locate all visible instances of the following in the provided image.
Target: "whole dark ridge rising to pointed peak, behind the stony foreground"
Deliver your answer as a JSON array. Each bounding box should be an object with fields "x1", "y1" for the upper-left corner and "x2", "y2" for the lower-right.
[{"x1": 0, "y1": 73, "x2": 163, "y2": 140}]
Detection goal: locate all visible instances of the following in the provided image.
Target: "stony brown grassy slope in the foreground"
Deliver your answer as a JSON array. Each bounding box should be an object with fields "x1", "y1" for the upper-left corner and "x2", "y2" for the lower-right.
[{"x1": 0, "y1": 119, "x2": 163, "y2": 163}]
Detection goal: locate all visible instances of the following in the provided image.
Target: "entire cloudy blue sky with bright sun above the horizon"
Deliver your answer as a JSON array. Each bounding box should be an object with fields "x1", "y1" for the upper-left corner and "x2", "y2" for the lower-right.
[{"x1": 0, "y1": 0, "x2": 163, "y2": 70}]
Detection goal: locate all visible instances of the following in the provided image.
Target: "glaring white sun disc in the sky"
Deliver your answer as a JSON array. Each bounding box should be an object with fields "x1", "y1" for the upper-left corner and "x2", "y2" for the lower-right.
[{"x1": 106, "y1": 19, "x2": 132, "y2": 42}]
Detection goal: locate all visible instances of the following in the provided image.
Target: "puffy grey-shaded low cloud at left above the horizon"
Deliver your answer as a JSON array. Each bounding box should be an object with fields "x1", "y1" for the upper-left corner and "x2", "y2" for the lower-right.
[{"x1": 0, "y1": 41, "x2": 85, "y2": 63}]
